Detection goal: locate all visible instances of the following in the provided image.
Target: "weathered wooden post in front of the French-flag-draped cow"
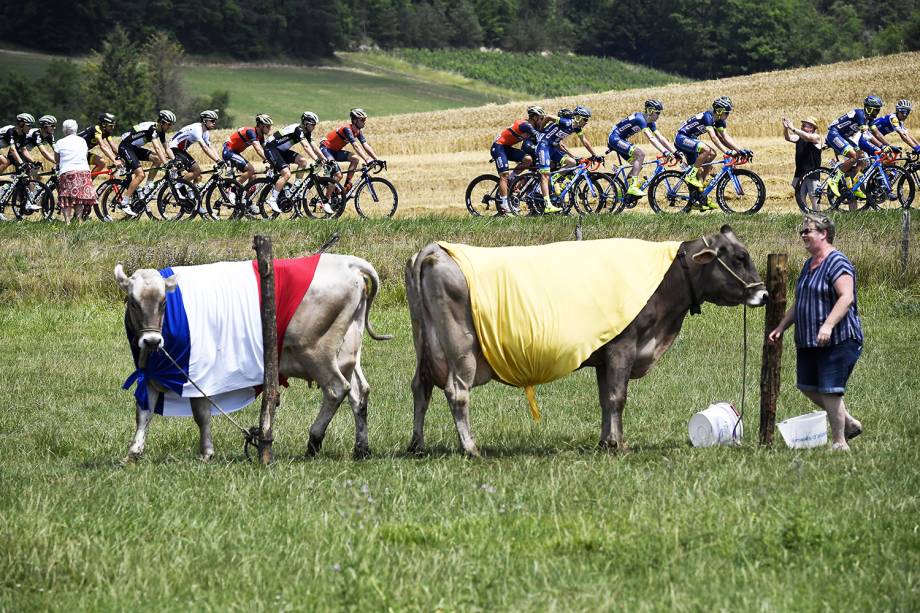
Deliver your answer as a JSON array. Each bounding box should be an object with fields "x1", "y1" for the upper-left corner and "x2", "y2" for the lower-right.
[{"x1": 252, "y1": 234, "x2": 278, "y2": 464}]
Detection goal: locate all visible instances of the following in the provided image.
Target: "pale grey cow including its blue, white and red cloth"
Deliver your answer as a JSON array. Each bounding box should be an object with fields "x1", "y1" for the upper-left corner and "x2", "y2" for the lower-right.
[{"x1": 115, "y1": 254, "x2": 390, "y2": 460}]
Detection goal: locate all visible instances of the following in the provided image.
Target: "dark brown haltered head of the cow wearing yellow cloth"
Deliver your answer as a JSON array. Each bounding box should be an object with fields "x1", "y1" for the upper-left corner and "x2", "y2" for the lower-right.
[{"x1": 687, "y1": 224, "x2": 767, "y2": 307}]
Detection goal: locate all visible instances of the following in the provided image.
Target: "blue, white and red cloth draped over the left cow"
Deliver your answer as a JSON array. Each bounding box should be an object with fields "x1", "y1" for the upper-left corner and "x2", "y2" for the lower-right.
[{"x1": 123, "y1": 254, "x2": 321, "y2": 416}]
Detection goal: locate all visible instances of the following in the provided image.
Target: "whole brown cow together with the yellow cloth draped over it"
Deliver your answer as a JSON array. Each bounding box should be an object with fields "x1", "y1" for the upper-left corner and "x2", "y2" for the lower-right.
[{"x1": 406, "y1": 225, "x2": 767, "y2": 456}]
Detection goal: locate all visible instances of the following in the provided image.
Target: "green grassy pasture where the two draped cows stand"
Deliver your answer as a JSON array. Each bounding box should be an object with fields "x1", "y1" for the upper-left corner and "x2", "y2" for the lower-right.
[{"x1": 0, "y1": 215, "x2": 920, "y2": 611}]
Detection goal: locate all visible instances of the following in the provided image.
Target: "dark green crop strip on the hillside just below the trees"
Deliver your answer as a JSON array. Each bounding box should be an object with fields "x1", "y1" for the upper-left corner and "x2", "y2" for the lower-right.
[{"x1": 382, "y1": 49, "x2": 687, "y2": 97}]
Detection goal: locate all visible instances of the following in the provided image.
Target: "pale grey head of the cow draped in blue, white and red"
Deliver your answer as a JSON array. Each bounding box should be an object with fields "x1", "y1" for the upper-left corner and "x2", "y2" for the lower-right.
[{"x1": 115, "y1": 264, "x2": 176, "y2": 368}]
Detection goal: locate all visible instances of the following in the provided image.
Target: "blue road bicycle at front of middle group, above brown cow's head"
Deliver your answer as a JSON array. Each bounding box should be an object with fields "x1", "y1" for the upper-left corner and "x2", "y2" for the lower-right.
[{"x1": 648, "y1": 153, "x2": 767, "y2": 215}]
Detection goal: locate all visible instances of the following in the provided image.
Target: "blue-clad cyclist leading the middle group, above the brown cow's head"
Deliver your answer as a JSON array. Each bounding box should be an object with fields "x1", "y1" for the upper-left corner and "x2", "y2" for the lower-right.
[{"x1": 674, "y1": 96, "x2": 753, "y2": 211}]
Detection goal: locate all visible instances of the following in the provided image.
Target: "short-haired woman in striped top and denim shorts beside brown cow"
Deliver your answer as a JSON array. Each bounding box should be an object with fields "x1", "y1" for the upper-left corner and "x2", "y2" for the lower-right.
[{"x1": 768, "y1": 215, "x2": 863, "y2": 451}]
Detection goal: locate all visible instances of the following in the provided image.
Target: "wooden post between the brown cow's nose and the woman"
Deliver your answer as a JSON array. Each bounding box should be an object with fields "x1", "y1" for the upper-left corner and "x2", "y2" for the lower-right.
[{"x1": 760, "y1": 253, "x2": 787, "y2": 445}]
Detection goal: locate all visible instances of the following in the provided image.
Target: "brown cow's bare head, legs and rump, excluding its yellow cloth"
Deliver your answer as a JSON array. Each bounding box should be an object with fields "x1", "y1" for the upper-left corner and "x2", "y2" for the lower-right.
[{"x1": 406, "y1": 225, "x2": 767, "y2": 456}]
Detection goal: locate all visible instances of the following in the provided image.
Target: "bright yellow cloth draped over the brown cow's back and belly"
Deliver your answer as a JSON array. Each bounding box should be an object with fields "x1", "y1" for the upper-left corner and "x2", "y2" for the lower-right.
[{"x1": 438, "y1": 238, "x2": 680, "y2": 420}]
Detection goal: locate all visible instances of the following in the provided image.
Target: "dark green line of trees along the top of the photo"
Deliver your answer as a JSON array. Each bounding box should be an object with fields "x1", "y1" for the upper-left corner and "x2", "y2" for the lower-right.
[{"x1": 0, "y1": 0, "x2": 920, "y2": 78}]
